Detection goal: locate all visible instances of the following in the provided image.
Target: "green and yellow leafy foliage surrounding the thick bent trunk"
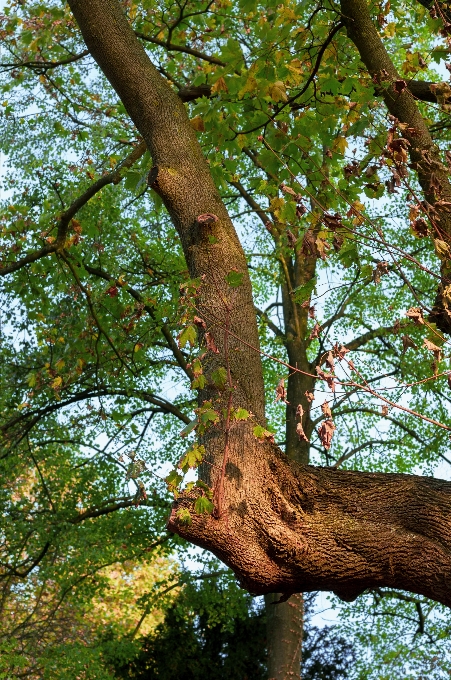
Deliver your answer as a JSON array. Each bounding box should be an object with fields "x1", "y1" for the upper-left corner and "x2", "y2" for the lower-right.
[{"x1": 0, "y1": 0, "x2": 450, "y2": 678}]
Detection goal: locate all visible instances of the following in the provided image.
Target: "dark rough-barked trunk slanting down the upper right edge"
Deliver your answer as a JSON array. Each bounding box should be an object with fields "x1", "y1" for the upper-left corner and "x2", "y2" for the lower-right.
[{"x1": 341, "y1": 0, "x2": 451, "y2": 334}]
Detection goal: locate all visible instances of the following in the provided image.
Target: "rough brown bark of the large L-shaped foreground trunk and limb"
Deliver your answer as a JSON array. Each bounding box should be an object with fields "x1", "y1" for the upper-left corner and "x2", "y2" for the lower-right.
[{"x1": 69, "y1": 0, "x2": 451, "y2": 616}]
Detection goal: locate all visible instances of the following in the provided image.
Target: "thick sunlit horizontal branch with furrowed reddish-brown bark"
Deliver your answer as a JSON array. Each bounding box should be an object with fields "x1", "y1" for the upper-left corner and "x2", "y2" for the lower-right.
[{"x1": 170, "y1": 438, "x2": 451, "y2": 606}]
